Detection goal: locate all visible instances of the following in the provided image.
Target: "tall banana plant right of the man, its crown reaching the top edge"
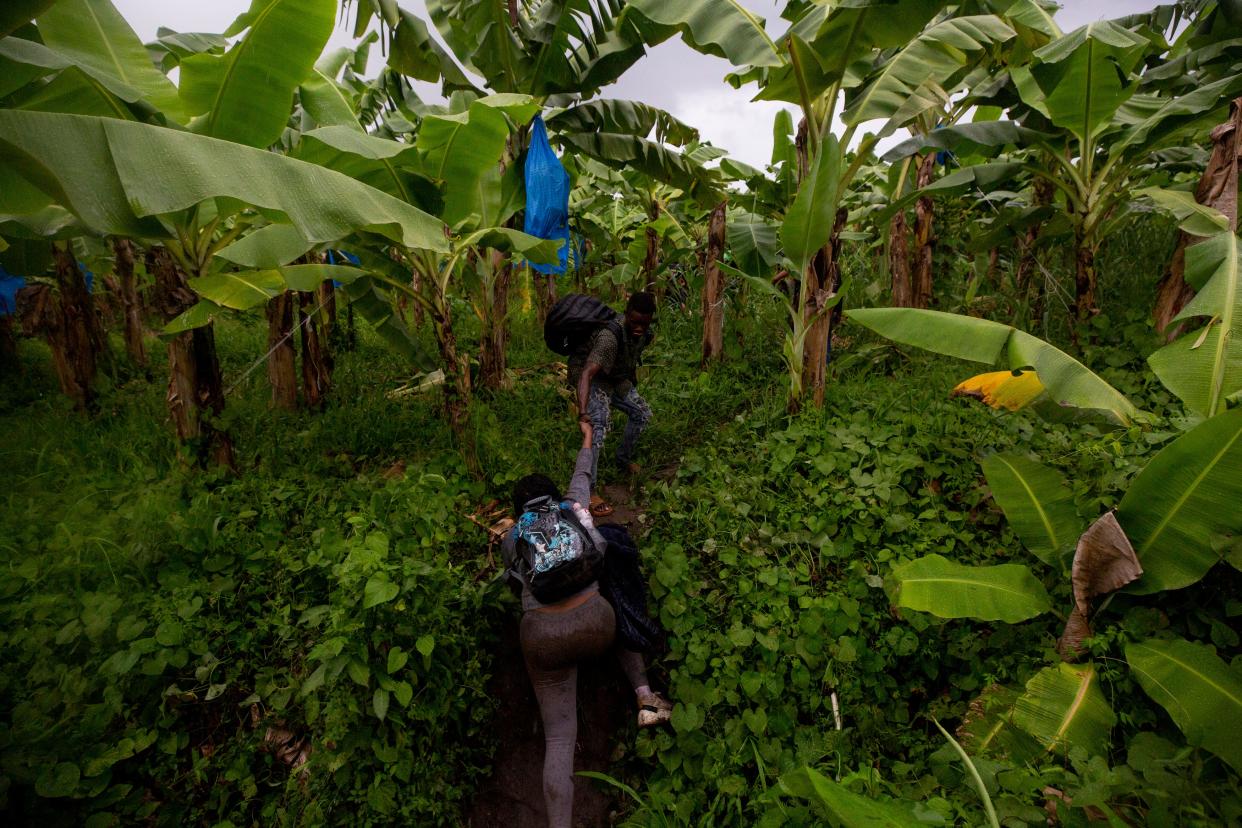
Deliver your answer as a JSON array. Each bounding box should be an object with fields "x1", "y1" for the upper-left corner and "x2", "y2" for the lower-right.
[{"x1": 623, "y1": 0, "x2": 1038, "y2": 410}]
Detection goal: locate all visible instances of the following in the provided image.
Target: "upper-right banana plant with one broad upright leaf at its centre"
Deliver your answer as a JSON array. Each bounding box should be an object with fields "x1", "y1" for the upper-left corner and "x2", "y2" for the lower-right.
[{"x1": 884, "y1": 12, "x2": 1242, "y2": 323}]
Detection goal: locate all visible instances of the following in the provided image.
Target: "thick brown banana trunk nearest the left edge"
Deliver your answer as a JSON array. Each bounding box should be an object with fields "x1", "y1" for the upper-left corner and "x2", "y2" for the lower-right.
[{"x1": 46, "y1": 243, "x2": 103, "y2": 411}]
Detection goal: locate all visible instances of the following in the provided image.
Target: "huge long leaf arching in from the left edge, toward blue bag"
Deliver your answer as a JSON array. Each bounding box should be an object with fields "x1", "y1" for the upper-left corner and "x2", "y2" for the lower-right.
[{"x1": 0, "y1": 110, "x2": 447, "y2": 251}]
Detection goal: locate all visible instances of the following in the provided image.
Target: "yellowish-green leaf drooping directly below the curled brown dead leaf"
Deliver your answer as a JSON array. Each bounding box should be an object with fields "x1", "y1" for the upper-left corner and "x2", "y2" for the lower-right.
[{"x1": 1011, "y1": 663, "x2": 1117, "y2": 756}]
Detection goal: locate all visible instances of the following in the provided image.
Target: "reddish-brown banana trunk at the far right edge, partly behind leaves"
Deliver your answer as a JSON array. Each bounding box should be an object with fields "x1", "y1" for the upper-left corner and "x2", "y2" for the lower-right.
[{"x1": 1151, "y1": 98, "x2": 1242, "y2": 341}]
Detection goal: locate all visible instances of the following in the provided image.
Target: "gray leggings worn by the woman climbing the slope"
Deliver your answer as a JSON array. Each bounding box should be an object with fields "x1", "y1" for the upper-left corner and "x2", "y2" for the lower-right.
[{"x1": 522, "y1": 593, "x2": 647, "y2": 828}]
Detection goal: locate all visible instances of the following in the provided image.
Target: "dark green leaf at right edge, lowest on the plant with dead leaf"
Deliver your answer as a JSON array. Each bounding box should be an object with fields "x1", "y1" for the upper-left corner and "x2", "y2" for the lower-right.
[{"x1": 1125, "y1": 638, "x2": 1242, "y2": 772}]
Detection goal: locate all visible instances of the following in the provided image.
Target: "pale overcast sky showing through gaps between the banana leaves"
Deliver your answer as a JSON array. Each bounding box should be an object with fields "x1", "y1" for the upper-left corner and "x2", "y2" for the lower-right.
[{"x1": 114, "y1": 0, "x2": 1156, "y2": 168}]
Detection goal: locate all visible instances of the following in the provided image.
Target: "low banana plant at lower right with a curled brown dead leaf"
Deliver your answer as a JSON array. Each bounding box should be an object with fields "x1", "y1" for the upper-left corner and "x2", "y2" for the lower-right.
[{"x1": 851, "y1": 296, "x2": 1242, "y2": 768}]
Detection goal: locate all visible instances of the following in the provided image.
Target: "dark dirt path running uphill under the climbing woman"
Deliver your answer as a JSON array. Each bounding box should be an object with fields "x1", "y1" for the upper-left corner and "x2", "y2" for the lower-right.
[{"x1": 466, "y1": 483, "x2": 642, "y2": 828}]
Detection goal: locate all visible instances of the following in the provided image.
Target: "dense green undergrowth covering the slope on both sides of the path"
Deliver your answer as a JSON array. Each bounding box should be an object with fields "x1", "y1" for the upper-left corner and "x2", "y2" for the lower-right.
[{"x1": 0, "y1": 273, "x2": 1242, "y2": 827}]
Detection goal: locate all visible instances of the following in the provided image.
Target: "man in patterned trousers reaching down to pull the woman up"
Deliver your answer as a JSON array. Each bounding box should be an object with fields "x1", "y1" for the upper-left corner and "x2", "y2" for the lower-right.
[{"x1": 569, "y1": 292, "x2": 656, "y2": 516}]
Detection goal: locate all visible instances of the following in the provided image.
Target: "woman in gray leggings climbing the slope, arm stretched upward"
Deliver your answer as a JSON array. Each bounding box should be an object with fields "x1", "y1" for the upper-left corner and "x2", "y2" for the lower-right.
[{"x1": 502, "y1": 422, "x2": 673, "y2": 828}]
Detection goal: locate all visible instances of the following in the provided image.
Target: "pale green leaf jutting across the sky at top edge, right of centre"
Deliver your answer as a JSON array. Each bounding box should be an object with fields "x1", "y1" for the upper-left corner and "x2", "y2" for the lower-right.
[{"x1": 626, "y1": 0, "x2": 785, "y2": 66}]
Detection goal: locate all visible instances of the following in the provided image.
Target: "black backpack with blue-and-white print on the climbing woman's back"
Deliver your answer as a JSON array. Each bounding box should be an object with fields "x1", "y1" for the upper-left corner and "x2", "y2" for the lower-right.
[{"x1": 512, "y1": 495, "x2": 604, "y2": 603}]
